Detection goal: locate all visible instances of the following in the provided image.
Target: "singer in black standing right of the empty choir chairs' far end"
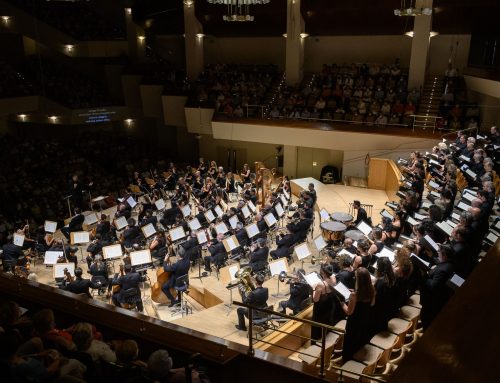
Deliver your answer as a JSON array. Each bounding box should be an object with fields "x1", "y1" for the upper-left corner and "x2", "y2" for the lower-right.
[{"x1": 420, "y1": 245, "x2": 454, "y2": 330}]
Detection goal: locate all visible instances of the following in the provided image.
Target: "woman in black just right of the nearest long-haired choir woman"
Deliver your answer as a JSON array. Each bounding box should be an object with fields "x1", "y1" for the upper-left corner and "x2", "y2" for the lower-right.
[{"x1": 370, "y1": 257, "x2": 398, "y2": 335}]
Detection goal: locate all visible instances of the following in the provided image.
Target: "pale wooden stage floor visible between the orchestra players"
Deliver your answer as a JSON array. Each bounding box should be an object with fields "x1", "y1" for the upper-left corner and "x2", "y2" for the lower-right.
[{"x1": 32, "y1": 178, "x2": 387, "y2": 344}]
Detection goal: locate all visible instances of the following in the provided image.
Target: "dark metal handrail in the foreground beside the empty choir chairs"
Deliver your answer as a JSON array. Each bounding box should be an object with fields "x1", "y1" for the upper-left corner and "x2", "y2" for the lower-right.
[{"x1": 233, "y1": 301, "x2": 387, "y2": 383}]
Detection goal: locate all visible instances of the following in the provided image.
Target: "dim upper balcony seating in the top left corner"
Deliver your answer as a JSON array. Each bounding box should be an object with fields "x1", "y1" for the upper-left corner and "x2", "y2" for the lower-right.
[{"x1": 8, "y1": 0, "x2": 126, "y2": 40}]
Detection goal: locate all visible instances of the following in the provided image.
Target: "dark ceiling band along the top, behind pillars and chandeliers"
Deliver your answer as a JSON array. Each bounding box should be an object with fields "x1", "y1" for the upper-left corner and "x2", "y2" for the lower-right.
[{"x1": 133, "y1": 0, "x2": 500, "y2": 37}]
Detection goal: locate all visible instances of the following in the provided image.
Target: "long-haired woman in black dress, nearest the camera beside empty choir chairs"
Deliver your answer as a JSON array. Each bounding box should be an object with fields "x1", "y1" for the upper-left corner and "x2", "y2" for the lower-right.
[{"x1": 342, "y1": 267, "x2": 375, "y2": 363}]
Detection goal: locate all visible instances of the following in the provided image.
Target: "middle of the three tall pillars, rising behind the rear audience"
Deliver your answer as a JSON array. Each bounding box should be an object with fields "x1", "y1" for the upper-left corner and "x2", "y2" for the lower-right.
[{"x1": 285, "y1": 0, "x2": 305, "y2": 86}]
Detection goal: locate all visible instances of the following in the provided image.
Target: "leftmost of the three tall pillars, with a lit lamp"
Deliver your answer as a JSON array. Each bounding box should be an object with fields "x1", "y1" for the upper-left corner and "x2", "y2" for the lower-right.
[{"x1": 184, "y1": 2, "x2": 203, "y2": 81}]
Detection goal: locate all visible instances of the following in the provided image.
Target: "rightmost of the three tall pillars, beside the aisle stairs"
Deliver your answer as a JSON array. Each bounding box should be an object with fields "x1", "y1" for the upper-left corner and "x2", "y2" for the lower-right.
[{"x1": 408, "y1": 0, "x2": 432, "y2": 89}]
